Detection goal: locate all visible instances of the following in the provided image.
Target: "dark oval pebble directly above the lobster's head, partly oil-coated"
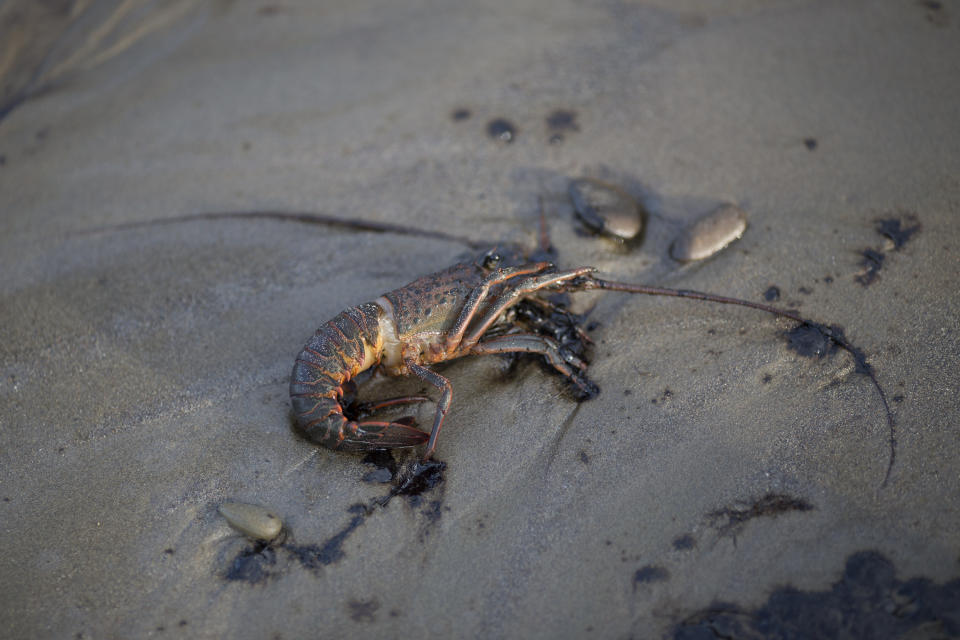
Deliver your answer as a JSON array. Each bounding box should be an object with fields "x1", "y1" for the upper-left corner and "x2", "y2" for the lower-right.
[{"x1": 568, "y1": 178, "x2": 643, "y2": 240}]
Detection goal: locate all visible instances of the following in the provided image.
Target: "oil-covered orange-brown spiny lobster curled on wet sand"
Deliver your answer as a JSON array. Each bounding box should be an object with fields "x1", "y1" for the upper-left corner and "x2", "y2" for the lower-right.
[{"x1": 290, "y1": 249, "x2": 892, "y2": 472}]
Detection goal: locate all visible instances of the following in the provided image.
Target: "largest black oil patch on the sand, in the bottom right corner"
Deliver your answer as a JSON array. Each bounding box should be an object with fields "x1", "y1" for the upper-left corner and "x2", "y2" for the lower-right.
[{"x1": 673, "y1": 551, "x2": 960, "y2": 640}]
